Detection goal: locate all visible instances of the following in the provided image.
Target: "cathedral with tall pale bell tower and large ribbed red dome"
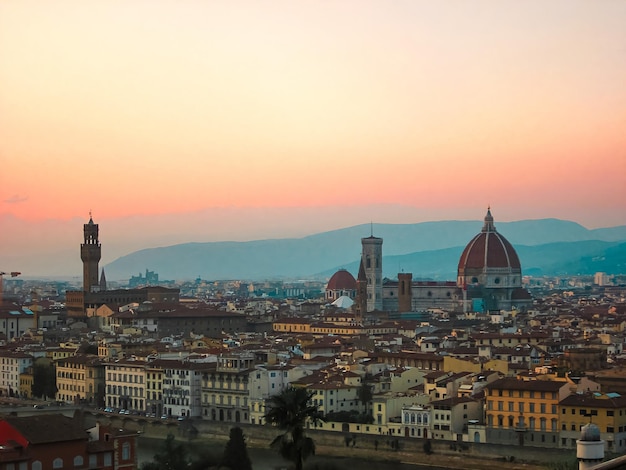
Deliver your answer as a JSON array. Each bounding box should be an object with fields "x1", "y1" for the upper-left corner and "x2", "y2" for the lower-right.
[{"x1": 346, "y1": 209, "x2": 532, "y2": 314}]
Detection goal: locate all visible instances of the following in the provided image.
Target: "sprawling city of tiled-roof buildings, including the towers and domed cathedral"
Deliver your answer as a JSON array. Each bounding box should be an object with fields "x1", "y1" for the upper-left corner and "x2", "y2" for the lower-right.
[{"x1": 0, "y1": 211, "x2": 626, "y2": 468}]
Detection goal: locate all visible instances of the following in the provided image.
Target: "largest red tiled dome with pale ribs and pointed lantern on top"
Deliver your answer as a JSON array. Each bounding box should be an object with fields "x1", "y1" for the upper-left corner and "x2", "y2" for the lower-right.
[{"x1": 459, "y1": 210, "x2": 521, "y2": 275}]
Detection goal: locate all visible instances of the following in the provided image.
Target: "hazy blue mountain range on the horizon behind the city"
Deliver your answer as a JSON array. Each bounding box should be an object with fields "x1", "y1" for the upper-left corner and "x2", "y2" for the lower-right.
[{"x1": 103, "y1": 219, "x2": 626, "y2": 280}]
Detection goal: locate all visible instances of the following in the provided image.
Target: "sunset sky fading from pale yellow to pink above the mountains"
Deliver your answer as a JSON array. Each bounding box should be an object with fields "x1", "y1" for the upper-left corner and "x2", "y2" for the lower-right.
[{"x1": 0, "y1": 0, "x2": 626, "y2": 274}]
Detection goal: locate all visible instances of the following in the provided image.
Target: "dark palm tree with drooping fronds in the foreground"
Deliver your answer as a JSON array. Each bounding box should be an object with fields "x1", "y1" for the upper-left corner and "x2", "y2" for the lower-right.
[{"x1": 265, "y1": 387, "x2": 321, "y2": 470}]
